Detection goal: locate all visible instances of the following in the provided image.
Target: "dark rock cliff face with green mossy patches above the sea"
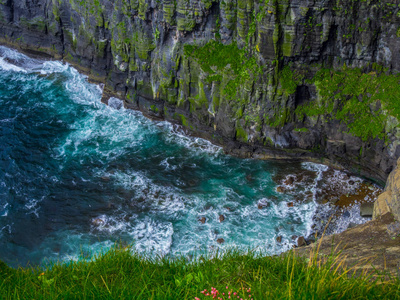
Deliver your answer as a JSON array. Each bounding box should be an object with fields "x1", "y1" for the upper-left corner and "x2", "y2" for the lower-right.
[{"x1": 0, "y1": 0, "x2": 400, "y2": 182}]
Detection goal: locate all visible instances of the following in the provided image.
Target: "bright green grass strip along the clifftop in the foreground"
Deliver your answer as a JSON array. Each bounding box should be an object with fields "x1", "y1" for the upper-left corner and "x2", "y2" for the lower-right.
[{"x1": 0, "y1": 248, "x2": 400, "y2": 300}]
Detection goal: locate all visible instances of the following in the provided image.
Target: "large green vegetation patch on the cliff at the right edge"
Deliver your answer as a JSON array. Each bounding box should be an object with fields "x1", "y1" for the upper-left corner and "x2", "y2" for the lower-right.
[{"x1": 296, "y1": 65, "x2": 400, "y2": 141}]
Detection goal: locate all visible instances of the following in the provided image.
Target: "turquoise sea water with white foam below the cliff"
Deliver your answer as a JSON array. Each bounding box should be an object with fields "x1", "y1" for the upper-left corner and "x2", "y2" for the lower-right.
[{"x1": 0, "y1": 47, "x2": 379, "y2": 266}]
